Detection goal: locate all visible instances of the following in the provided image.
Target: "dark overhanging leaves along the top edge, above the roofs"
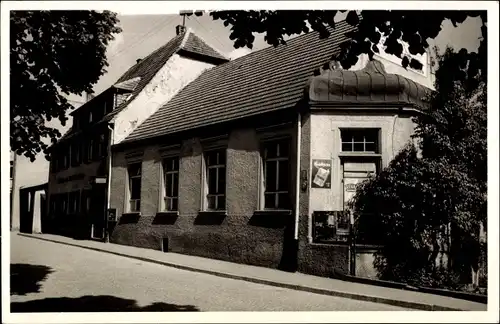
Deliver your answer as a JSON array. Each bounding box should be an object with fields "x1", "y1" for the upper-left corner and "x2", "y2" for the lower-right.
[{"x1": 198, "y1": 10, "x2": 487, "y2": 76}]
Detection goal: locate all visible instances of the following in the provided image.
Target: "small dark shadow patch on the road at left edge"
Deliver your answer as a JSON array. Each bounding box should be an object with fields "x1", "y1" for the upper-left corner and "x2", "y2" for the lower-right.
[{"x1": 10, "y1": 264, "x2": 53, "y2": 295}]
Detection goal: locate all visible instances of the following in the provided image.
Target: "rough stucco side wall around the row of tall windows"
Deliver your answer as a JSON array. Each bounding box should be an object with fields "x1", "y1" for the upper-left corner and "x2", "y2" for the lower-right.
[{"x1": 111, "y1": 122, "x2": 295, "y2": 267}]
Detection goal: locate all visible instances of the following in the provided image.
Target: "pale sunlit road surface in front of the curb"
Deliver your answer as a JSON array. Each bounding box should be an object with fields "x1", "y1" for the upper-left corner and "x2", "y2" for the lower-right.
[{"x1": 11, "y1": 235, "x2": 407, "y2": 312}]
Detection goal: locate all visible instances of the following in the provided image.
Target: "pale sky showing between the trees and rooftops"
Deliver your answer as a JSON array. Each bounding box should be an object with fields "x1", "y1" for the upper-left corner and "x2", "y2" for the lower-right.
[{"x1": 85, "y1": 14, "x2": 481, "y2": 99}]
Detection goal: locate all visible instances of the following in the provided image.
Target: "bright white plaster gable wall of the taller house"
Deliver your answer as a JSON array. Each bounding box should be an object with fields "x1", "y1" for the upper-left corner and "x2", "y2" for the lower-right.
[{"x1": 113, "y1": 54, "x2": 213, "y2": 144}]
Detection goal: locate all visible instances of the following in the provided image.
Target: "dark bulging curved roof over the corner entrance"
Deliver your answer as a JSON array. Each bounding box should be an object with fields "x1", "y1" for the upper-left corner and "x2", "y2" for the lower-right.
[{"x1": 305, "y1": 60, "x2": 430, "y2": 108}]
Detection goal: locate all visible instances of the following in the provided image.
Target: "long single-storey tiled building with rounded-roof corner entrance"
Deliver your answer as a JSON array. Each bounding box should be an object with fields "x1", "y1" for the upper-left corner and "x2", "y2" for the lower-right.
[{"x1": 110, "y1": 22, "x2": 434, "y2": 276}]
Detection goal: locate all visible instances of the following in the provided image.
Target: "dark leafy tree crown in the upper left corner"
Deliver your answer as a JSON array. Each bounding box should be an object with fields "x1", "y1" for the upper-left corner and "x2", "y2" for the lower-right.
[{"x1": 10, "y1": 11, "x2": 121, "y2": 161}]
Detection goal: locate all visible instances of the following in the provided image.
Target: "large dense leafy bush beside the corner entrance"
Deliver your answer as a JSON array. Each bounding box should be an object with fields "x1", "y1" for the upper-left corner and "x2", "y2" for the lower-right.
[{"x1": 351, "y1": 48, "x2": 487, "y2": 287}]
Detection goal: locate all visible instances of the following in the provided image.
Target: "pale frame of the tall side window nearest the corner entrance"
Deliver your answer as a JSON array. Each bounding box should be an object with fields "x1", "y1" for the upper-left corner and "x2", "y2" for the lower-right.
[{"x1": 259, "y1": 135, "x2": 292, "y2": 211}]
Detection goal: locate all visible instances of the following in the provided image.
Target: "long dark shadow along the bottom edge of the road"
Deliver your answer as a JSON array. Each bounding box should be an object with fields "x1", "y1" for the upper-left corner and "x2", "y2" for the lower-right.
[{"x1": 10, "y1": 296, "x2": 199, "y2": 313}]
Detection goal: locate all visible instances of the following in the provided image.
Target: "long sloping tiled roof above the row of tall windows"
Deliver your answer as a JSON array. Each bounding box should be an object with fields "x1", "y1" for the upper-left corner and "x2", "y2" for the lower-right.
[{"x1": 123, "y1": 21, "x2": 353, "y2": 143}]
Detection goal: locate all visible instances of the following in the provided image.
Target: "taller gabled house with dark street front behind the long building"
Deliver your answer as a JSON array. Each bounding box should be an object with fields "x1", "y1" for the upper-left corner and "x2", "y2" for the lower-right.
[{"x1": 43, "y1": 26, "x2": 227, "y2": 238}]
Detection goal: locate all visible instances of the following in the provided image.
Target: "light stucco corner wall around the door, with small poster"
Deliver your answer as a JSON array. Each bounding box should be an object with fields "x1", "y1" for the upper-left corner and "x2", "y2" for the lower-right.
[{"x1": 298, "y1": 112, "x2": 414, "y2": 276}]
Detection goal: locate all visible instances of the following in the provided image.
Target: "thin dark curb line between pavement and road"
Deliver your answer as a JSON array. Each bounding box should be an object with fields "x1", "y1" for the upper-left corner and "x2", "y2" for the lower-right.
[{"x1": 17, "y1": 233, "x2": 463, "y2": 311}]
